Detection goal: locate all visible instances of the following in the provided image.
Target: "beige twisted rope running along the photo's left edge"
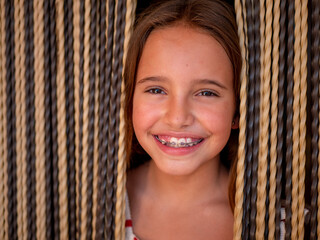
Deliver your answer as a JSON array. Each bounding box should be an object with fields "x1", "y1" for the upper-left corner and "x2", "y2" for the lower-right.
[{"x1": 0, "y1": 0, "x2": 9, "y2": 240}]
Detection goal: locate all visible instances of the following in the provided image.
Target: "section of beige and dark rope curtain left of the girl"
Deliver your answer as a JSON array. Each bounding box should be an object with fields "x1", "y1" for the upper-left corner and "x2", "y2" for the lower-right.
[{"x1": 0, "y1": 0, "x2": 136, "y2": 240}]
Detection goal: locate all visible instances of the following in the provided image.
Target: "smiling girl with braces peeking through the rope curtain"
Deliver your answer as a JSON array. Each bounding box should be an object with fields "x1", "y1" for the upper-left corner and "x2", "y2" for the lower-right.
[{"x1": 124, "y1": 0, "x2": 241, "y2": 240}]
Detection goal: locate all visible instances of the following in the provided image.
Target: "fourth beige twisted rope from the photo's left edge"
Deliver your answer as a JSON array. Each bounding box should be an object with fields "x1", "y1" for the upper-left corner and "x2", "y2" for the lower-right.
[{"x1": 56, "y1": 1, "x2": 68, "y2": 239}]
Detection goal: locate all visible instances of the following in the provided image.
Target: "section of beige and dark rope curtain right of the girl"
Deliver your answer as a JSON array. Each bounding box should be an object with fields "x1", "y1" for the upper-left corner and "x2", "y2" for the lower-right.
[{"x1": 234, "y1": 0, "x2": 320, "y2": 239}]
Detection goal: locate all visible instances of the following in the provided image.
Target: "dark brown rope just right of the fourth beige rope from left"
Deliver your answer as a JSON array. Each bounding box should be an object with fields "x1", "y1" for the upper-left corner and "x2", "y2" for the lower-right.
[{"x1": 64, "y1": 0, "x2": 76, "y2": 239}]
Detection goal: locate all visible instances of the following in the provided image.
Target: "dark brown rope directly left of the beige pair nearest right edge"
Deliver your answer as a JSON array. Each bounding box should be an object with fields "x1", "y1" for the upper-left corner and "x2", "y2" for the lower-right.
[{"x1": 285, "y1": 1, "x2": 294, "y2": 240}]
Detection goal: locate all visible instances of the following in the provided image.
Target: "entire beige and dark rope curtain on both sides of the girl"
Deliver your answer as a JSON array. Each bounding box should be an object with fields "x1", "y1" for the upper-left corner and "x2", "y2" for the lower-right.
[{"x1": 0, "y1": 0, "x2": 320, "y2": 240}]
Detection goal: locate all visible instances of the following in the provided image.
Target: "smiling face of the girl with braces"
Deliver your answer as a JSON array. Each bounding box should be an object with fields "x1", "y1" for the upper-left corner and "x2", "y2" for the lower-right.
[{"x1": 133, "y1": 24, "x2": 237, "y2": 175}]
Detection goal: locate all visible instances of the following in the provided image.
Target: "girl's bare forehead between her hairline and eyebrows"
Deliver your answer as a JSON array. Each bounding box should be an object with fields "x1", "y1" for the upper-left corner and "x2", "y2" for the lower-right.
[{"x1": 137, "y1": 24, "x2": 233, "y2": 86}]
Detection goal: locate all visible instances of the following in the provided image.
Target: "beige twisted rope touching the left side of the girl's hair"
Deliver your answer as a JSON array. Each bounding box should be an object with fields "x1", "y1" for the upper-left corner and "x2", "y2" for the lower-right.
[{"x1": 115, "y1": 0, "x2": 137, "y2": 239}]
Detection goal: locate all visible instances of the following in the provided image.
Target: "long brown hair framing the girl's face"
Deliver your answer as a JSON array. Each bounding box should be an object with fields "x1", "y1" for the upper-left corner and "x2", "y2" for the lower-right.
[{"x1": 124, "y1": 0, "x2": 242, "y2": 209}]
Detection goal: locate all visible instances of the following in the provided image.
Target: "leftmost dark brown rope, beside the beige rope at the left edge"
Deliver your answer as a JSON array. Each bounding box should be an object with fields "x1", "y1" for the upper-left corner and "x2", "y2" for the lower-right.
[{"x1": 4, "y1": 1, "x2": 18, "y2": 239}]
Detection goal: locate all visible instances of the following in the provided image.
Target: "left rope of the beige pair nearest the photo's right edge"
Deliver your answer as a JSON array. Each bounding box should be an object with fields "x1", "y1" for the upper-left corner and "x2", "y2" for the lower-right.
[{"x1": 291, "y1": 0, "x2": 301, "y2": 239}]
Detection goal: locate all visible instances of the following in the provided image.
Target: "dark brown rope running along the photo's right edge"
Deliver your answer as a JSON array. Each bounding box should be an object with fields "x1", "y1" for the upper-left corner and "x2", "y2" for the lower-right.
[{"x1": 310, "y1": 0, "x2": 320, "y2": 239}]
